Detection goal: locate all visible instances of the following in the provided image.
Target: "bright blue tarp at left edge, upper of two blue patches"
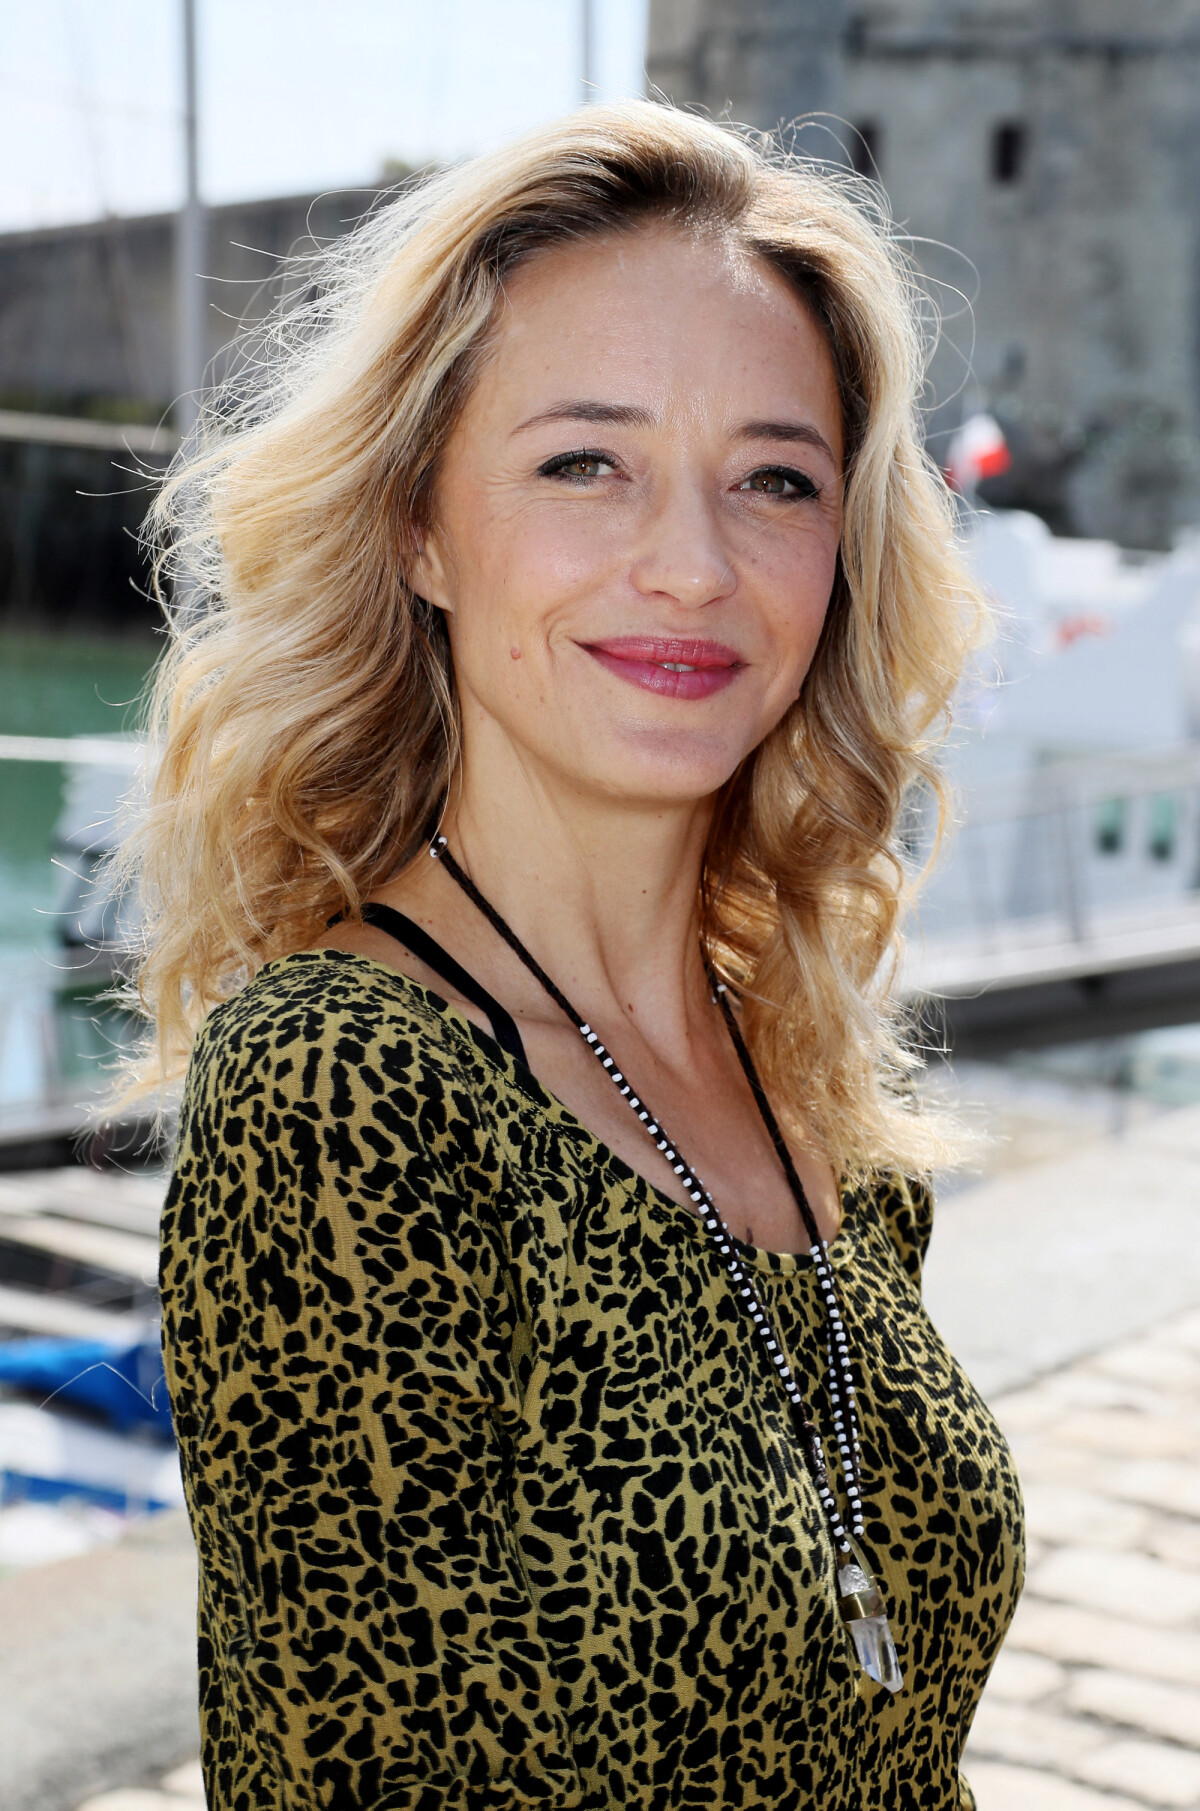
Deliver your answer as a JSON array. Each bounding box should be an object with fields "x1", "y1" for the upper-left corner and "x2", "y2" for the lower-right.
[{"x1": 0, "y1": 1338, "x2": 174, "y2": 1440}]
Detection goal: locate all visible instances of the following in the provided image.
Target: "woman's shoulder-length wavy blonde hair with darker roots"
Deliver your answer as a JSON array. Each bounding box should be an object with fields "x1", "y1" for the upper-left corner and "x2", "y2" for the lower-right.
[{"x1": 121, "y1": 101, "x2": 983, "y2": 1175}]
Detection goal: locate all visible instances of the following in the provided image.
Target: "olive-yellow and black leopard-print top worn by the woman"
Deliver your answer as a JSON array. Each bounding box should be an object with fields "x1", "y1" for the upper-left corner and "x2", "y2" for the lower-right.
[{"x1": 163, "y1": 951, "x2": 1023, "y2": 1811}]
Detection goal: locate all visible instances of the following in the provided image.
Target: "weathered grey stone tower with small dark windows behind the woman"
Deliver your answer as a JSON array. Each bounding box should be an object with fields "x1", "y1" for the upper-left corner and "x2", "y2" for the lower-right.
[{"x1": 648, "y1": 0, "x2": 1200, "y2": 547}]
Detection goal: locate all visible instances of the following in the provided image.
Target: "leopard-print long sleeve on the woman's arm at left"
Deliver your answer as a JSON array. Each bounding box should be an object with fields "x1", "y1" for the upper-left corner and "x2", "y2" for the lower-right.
[{"x1": 163, "y1": 977, "x2": 581, "y2": 1811}]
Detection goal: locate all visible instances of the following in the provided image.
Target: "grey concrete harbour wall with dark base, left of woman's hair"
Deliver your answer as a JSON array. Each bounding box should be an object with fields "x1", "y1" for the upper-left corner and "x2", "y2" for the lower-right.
[{"x1": 0, "y1": 188, "x2": 378, "y2": 628}]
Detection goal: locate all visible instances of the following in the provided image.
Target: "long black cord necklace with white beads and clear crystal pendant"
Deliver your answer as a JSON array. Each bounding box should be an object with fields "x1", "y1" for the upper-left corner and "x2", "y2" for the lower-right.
[{"x1": 429, "y1": 835, "x2": 903, "y2": 1691}]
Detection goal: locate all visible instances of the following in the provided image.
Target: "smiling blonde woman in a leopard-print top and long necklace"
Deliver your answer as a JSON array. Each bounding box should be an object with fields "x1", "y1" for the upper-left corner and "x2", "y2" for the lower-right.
[{"x1": 139, "y1": 105, "x2": 1021, "y2": 1811}]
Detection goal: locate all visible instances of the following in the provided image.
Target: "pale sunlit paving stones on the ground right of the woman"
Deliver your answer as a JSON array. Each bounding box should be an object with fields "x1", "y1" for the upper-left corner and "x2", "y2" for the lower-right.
[{"x1": 967, "y1": 1309, "x2": 1200, "y2": 1811}]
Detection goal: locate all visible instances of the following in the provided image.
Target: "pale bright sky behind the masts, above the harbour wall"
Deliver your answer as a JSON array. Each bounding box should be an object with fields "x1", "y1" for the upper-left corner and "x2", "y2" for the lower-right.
[{"x1": 0, "y1": 0, "x2": 648, "y2": 232}]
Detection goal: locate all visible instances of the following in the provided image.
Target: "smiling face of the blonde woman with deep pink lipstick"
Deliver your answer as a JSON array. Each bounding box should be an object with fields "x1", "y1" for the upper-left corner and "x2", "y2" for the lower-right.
[{"x1": 413, "y1": 228, "x2": 842, "y2": 804}]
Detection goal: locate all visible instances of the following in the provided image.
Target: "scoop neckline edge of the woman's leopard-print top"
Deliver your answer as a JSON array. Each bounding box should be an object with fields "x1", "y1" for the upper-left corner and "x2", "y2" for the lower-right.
[{"x1": 255, "y1": 949, "x2": 854, "y2": 1275}]
